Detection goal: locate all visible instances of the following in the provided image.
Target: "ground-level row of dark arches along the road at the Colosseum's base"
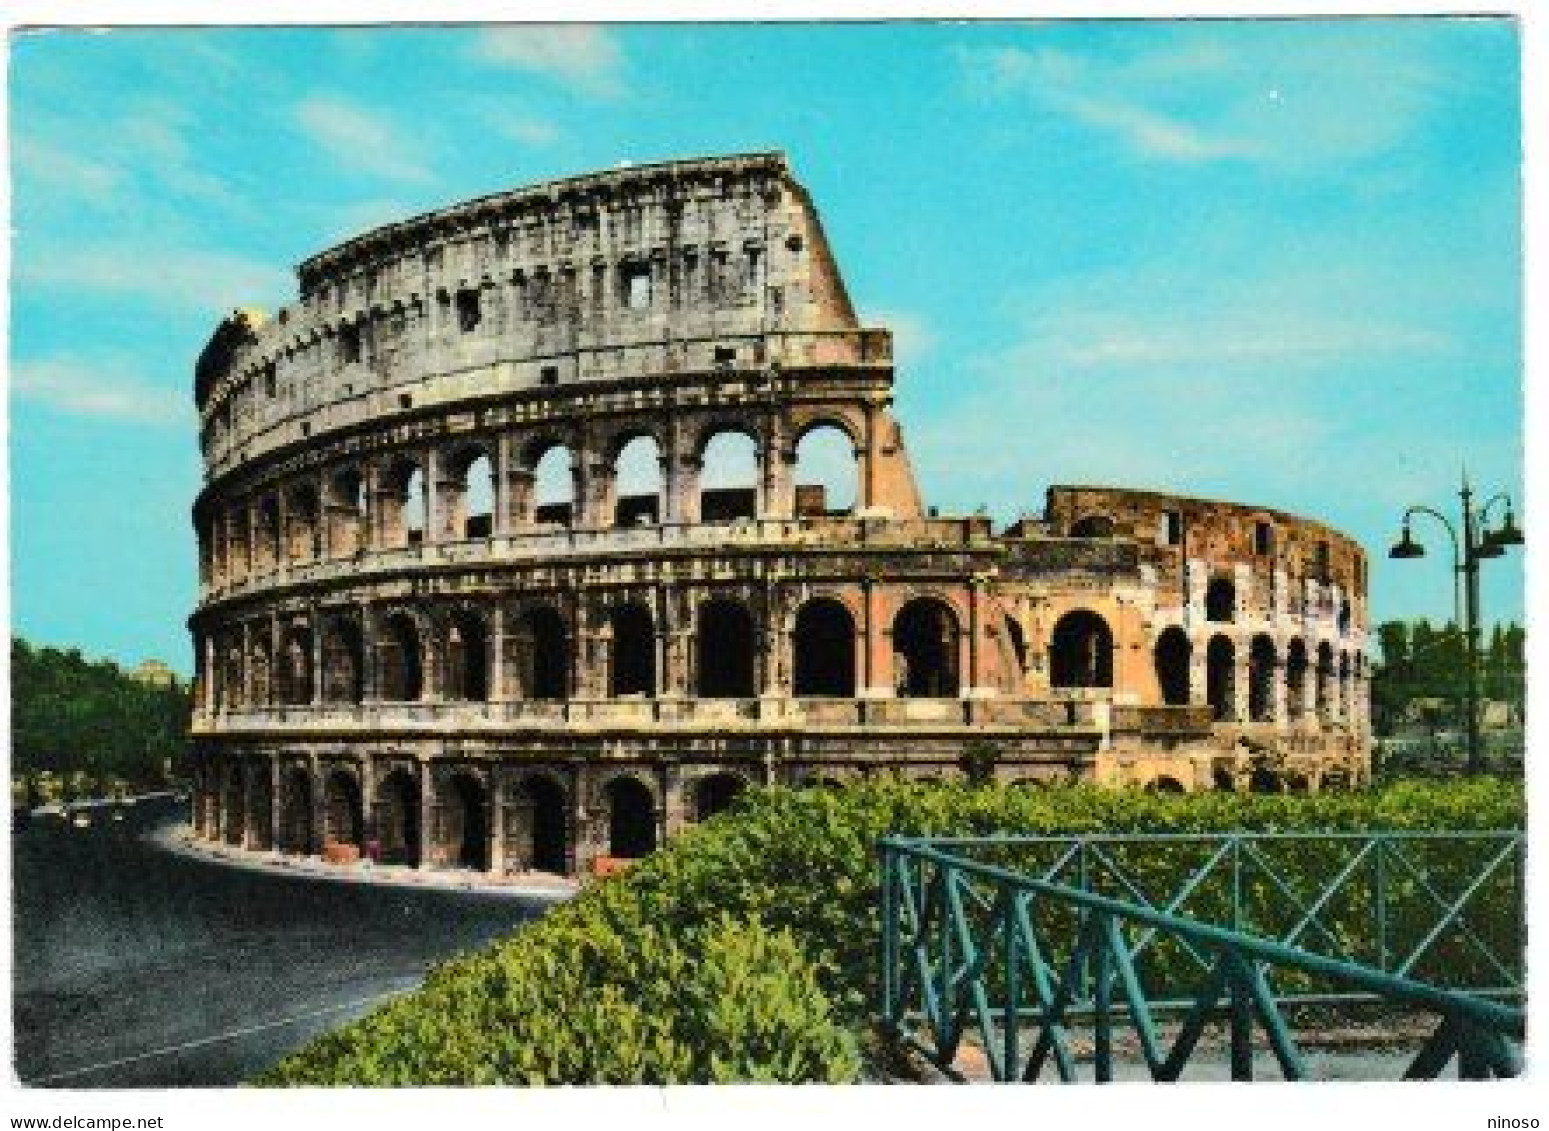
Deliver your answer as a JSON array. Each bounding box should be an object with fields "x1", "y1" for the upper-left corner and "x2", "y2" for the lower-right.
[{"x1": 197, "y1": 764, "x2": 748, "y2": 874}]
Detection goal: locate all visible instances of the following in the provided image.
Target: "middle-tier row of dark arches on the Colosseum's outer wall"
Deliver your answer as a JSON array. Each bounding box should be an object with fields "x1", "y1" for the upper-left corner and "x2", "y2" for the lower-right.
[{"x1": 212, "y1": 596, "x2": 960, "y2": 710}]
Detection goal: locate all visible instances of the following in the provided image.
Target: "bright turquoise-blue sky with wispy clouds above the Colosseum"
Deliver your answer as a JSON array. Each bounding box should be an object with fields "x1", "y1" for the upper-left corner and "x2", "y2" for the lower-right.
[{"x1": 9, "y1": 19, "x2": 1535, "y2": 671}]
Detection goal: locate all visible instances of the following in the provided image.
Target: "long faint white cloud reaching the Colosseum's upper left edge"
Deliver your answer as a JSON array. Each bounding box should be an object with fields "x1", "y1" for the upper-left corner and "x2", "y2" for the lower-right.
[{"x1": 15, "y1": 243, "x2": 294, "y2": 313}]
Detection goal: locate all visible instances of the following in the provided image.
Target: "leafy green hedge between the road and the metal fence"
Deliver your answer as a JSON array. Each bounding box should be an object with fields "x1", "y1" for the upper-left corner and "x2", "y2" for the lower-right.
[{"x1": 259, "y1": 779, "x2": 1523, "y2": 1085}]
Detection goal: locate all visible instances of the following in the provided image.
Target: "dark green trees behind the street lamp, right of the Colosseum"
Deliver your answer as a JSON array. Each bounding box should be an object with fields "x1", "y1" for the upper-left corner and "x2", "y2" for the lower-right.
[{"x1": 1371, "y1": 620, "x2": 1527, "y2": 731}]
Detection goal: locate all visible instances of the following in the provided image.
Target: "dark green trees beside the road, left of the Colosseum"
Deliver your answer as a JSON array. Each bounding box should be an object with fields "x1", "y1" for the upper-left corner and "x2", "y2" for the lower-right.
[{"x1": 11, "y1": 637, "x2": 191, "y2": 787}]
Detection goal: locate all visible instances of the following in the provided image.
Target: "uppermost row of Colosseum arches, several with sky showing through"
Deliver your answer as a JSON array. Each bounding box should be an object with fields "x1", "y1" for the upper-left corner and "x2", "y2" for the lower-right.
[{"x1": 200, "y1": 417, "x2": 861, "y2": 584}]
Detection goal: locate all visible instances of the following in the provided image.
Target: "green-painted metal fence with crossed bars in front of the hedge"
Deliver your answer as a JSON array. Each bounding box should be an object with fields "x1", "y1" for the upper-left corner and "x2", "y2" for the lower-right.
[{"x1": 878, "y1": 830, "x2": 1526, "y2": 1081}]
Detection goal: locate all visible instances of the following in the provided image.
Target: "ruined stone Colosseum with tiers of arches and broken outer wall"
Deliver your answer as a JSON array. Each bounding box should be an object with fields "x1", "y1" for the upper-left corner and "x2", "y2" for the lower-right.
[{"x1": 189, "y1": 153, "x2": 1369, "y2": 875}]
